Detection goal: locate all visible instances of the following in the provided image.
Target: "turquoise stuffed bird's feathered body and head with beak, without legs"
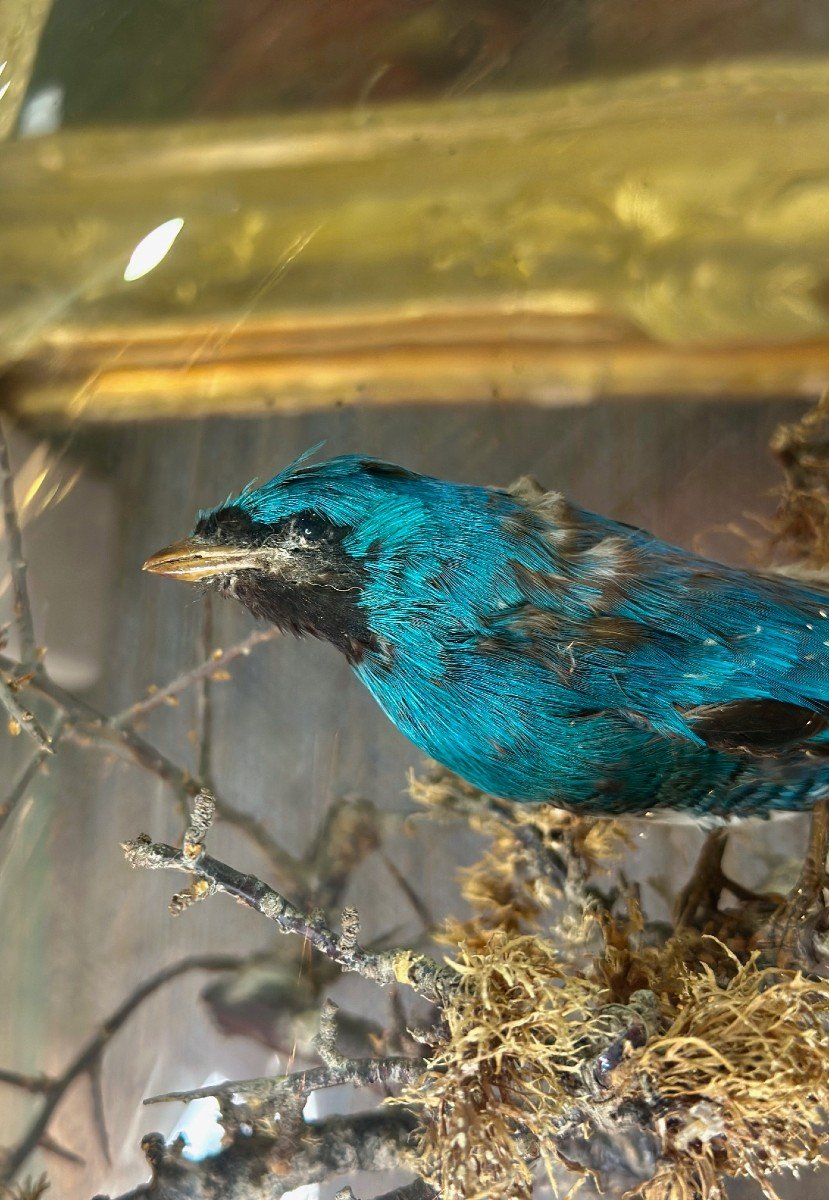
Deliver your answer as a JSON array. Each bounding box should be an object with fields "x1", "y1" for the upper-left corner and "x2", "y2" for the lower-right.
[{"x1": 144, "y1": 451, "x2": 829, "y2": 818}]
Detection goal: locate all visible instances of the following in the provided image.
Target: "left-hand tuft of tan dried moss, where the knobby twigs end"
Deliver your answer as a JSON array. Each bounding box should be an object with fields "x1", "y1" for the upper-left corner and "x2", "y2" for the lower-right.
[{"x1": 404, "y1": 930, "x2": 612, "y2": 1200}]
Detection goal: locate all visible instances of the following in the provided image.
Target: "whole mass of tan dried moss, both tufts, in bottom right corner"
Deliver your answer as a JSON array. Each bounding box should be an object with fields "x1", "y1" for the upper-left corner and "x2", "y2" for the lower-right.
[{"x1": 407, "y1": 911, "x2": 829, "y2": 1200}]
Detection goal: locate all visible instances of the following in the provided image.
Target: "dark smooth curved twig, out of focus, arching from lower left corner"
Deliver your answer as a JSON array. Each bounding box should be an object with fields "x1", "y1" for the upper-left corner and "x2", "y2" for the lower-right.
[{"x1": 0, "y1": 954, "x2": 244, "y2": 1184}]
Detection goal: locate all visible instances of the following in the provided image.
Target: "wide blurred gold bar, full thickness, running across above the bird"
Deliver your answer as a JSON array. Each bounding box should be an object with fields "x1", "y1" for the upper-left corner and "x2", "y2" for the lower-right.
[{"x1": 0, "y1": 61, "x2": 829, "y2": 419}]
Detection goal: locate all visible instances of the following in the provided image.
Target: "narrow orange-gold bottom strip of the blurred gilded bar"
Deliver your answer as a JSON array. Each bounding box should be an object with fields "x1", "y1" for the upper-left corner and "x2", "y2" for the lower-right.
[{"x1": 6, "y1": 342, "x2": 829, "y2": 422}]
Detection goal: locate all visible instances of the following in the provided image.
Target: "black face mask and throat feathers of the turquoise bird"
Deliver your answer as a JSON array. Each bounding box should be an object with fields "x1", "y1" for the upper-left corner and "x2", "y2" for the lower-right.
[{"x1": 193, "y1": 505, "x2": 376, "y2": 664}]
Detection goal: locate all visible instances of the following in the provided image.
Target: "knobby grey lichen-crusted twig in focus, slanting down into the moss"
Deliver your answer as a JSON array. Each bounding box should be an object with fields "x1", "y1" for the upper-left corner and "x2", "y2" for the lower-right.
[{"x1": 124, "y1": 834, "x2": 458, "y2": 1002}]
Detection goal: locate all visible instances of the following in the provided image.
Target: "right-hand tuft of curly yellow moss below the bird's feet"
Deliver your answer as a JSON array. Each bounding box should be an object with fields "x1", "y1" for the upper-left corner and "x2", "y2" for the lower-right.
[{"x1": 618, "y1": 955, "x2": 829, "y2": 1200}]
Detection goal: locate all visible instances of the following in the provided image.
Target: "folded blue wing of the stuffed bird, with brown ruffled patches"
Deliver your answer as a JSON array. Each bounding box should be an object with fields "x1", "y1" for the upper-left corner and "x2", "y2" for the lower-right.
[{"x1": 488, "y1": 526, "x2": 829, "y2": 754}]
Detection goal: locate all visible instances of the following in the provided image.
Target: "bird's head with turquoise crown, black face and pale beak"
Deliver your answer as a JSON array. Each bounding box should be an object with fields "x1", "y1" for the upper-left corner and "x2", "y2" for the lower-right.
[{"x1": 144, "y1": 455, "x2": 487, "y2": 662}]
